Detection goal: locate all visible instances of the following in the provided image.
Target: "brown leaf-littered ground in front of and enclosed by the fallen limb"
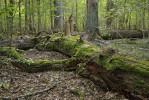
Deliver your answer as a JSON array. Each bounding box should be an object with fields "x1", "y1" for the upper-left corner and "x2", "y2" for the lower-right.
[{"x1": 0, "y1": 49, "x2": 126, "y2": 100}]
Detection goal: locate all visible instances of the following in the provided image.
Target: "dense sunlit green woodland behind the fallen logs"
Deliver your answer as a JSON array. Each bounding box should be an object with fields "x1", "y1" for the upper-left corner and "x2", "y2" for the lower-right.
[{"x1": 0, "y1": 0, "x2": 149, "y2": 35}]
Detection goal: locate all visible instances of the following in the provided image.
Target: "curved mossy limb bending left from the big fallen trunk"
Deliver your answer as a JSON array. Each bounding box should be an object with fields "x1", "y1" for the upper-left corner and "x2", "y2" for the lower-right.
[{"x1": 0, "y1": 47, "x2": 75, "y2": 72}]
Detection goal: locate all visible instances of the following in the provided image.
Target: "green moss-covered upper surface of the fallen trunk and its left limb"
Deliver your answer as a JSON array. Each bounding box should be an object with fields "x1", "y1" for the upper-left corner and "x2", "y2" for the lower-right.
[{"x1": 0, "y1": 36, "x2": 149, "y2": 77}]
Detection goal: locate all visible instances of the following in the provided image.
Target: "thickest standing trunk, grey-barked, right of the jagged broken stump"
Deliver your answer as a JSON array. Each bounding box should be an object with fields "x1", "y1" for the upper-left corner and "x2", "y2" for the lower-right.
[{"x1": 86, "y1": 0, "x2": 98, "y2": 40}]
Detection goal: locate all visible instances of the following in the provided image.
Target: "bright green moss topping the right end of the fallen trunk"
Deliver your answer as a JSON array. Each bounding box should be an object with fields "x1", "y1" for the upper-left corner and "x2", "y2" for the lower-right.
[{"x1": 104, "y1": 56, "x2": 149, "y2": 77}]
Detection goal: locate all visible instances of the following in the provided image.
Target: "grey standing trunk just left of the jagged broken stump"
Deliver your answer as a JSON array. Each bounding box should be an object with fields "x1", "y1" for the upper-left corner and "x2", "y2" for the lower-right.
[{"x1": 54, "y1": 0, "x2": 63, "y2": 32}]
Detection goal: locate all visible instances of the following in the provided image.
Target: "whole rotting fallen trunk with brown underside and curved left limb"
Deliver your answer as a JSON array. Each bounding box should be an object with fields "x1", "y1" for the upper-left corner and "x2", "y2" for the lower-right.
[{"x1": 0, "y1": 36, "x2": 149, "y2": 99}]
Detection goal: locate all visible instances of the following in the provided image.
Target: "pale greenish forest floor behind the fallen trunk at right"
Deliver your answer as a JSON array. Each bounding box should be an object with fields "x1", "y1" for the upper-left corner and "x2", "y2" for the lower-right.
[{"x1": 93, "y1": 38, "x2": 149, "y2": 61}]
